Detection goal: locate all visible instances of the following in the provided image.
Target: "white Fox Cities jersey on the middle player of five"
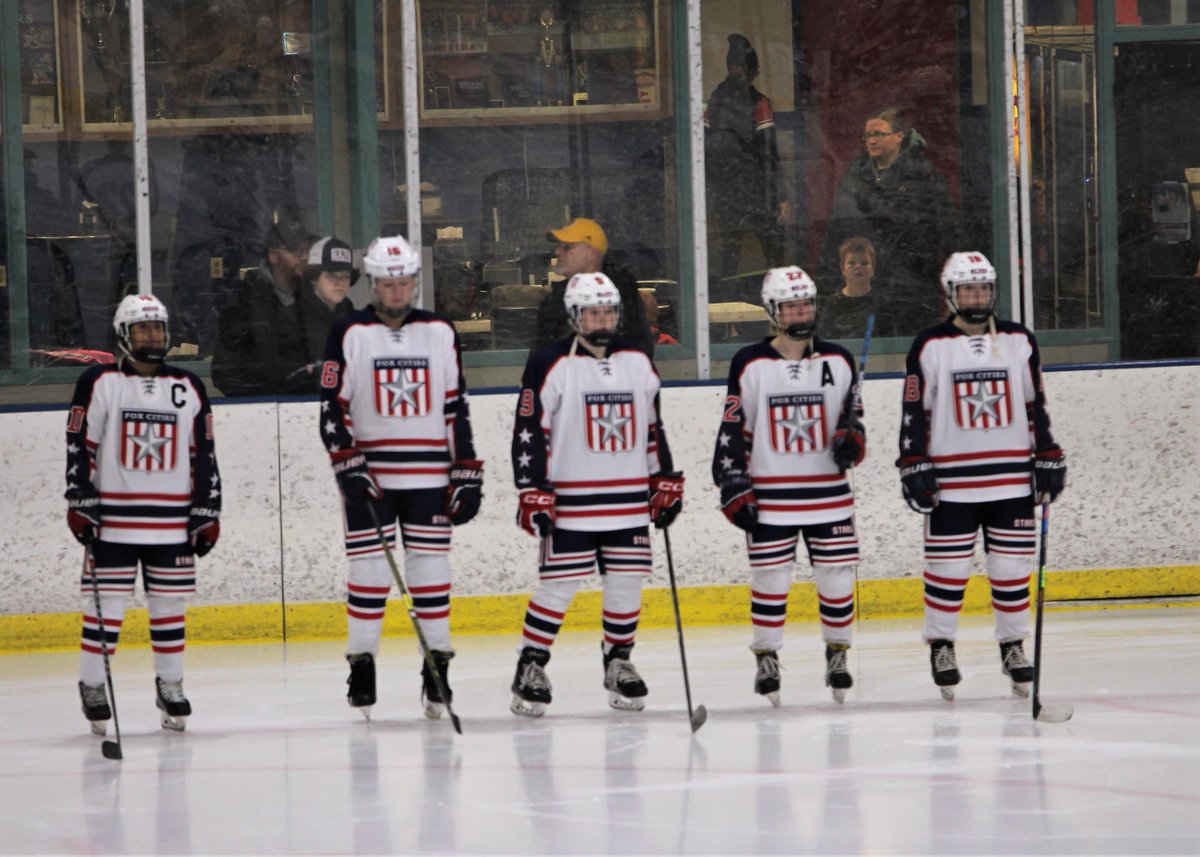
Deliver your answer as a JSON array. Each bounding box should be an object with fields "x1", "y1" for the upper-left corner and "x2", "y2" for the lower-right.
[{"x1": 512, "y1": 336, "x2": 673, "y2": 532}]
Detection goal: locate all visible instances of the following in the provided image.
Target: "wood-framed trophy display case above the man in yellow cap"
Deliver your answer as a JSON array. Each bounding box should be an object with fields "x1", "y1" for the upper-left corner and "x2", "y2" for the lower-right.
[{"x1": 418, "y1": 0, "x2": 670, "y2": 125}]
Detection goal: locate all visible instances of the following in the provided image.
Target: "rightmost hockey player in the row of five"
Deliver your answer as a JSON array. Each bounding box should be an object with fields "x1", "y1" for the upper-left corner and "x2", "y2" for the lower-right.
[{"x1": 896, "y1": 252, "x2": 1067, "y2": 700}]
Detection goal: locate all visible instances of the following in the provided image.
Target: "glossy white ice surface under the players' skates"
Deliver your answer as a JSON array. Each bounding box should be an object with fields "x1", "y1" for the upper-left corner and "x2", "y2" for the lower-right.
[{"x1": 0, "y1": 605, "x2": 1200, "y2": 855}]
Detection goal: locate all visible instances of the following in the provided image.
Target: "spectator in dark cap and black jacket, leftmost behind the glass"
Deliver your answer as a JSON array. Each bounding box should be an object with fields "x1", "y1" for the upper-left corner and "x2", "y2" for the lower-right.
[{"x1": 212, "y1": 208, "x2": 312, "y2": 396}]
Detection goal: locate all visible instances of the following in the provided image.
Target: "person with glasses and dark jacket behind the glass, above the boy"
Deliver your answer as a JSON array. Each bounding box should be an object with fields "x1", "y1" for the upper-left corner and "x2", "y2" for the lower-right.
[{"x1": 822, "y1": 107, "x2": 958, "y2": 335}]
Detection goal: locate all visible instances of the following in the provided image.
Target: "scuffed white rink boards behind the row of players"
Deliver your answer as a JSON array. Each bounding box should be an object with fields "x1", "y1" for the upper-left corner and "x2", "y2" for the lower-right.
[{"x1": 0, "y1": 365, "x2": 1200, "y2": 616}]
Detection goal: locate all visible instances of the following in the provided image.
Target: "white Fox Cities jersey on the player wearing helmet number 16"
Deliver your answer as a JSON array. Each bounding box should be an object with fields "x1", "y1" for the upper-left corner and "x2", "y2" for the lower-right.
[{"x1": 320, "y1": 306, "x2": 475, "y2": 491}]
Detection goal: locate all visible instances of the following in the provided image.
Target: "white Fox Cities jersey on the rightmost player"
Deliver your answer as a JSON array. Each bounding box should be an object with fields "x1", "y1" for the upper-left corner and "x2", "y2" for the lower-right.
[{"x1": 898, "y1": 320, "x2": 1054, "y2": 503}]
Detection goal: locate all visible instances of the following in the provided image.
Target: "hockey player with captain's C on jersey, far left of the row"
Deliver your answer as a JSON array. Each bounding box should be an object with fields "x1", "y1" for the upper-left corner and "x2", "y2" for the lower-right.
[{"x1": 66, "y1": 295, "x2": 221, "y2": 735}]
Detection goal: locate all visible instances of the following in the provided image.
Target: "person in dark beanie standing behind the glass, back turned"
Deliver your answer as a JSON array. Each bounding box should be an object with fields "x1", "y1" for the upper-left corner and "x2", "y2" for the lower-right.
[{"x1": 704, "y1": 32, "x2": 792, "y2": 300}]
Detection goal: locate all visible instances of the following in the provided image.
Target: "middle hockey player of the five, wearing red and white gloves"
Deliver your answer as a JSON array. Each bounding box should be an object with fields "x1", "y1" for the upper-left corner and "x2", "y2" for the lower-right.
[{"x1": 510, "y1": 272, "x2": 684, "y2": 717}]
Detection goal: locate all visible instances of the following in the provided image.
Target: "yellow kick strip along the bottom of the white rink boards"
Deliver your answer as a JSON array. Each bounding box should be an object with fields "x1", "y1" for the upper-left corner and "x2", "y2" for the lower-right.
[{"x1": 0, "y1": 565, "x2": 1200, "y2": 653}]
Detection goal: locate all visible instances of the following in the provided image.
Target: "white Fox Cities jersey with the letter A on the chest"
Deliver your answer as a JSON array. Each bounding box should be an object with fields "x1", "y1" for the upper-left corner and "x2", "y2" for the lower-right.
[{"x1": 713, "y1": 340, "x2": 862, "y2": 526}]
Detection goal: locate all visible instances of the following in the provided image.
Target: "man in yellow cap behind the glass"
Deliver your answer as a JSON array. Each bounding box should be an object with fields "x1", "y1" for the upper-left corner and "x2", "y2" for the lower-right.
[{"x1": 533, "y1": 217, "x2": 654, "y2": 358}]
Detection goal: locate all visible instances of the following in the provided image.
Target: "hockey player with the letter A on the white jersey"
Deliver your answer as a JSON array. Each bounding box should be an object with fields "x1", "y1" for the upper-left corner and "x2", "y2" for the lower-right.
[{"x1": 713, "y1": 265, "x2": 866, "y2": 706}]
